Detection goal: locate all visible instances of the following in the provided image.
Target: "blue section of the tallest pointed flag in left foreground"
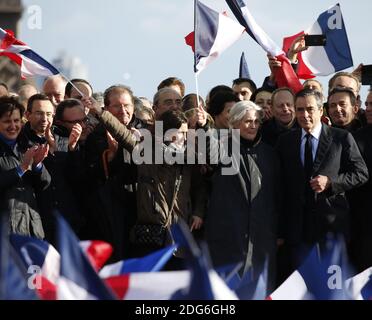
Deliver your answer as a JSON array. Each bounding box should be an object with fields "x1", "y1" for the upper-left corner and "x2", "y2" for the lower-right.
[{"x1": 56, "y1": 214, "x2": 115, "y2": 300}]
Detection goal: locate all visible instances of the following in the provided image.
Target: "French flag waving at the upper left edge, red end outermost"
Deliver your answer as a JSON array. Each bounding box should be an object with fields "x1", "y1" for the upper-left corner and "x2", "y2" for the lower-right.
[{"x1": 0, "y1": 28, "x2": 59, "y2": 78}]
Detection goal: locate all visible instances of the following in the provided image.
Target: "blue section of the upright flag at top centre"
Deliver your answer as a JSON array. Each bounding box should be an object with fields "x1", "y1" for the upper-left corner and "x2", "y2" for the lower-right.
[{"x1": 194, "y1": 1, "x2": 219, "y2": 72}]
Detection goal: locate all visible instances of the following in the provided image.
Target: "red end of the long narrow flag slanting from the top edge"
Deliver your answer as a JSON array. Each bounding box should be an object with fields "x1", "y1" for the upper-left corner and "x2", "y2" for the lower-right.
[{"x1": 275, "y1": 54, "x2": 303, "y2": 93}]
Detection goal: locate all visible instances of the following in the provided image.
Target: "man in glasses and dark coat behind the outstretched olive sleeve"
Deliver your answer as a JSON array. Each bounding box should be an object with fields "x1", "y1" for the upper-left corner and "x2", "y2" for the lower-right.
[{"x1": 83, "y1": 85, "x2": 137, "y2": 262}]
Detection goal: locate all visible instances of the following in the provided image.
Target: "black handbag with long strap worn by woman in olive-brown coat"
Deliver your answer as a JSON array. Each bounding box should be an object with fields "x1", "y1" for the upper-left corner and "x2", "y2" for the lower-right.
[{"x1": 131, "y1": 173, "x2": 182, "y2": 247}]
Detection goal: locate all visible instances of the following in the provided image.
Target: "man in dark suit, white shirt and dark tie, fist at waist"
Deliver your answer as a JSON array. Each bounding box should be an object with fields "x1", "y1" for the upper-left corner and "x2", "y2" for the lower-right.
[{"x1": 277, "y1": 89, "x2": 368, "y2": 270}]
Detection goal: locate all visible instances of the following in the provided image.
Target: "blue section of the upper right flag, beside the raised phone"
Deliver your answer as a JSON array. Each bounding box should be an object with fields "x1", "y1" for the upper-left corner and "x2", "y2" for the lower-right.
[{"x1": 317, "y1": 4, "x2": 354, "y2": 72}]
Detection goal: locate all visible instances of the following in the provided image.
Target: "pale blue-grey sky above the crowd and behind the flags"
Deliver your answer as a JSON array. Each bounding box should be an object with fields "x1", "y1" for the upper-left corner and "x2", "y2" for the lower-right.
[{"x1": 19, "y1": 0, "x2": 372, "y2": 99}]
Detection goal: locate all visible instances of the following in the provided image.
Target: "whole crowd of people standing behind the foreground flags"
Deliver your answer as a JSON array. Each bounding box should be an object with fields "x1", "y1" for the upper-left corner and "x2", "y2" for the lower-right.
[{"x1": 0, "y1": 48, "x2": 372, "y2": 289}]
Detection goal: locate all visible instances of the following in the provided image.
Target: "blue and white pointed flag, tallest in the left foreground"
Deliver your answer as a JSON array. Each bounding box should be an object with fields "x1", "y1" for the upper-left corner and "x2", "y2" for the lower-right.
[{"x1": 57, "y1": 215, "x2": 114, "y2": 300}]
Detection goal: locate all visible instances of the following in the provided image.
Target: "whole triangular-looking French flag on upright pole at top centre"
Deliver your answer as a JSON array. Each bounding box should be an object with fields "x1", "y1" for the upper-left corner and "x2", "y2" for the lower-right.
[{"x1": 185, "y1": 0, "x2": 244, "y2": 74}]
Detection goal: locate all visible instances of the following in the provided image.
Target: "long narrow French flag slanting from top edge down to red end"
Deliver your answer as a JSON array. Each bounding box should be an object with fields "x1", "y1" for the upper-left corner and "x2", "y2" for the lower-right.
[{"x1": 226, "y1": 0, "x2": 302, "y2": 92}]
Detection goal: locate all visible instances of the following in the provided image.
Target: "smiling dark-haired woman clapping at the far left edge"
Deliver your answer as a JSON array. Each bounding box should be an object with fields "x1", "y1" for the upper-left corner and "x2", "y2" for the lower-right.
[{"x1": 0, "y1": 97, "x2": 50, "y2": 238}]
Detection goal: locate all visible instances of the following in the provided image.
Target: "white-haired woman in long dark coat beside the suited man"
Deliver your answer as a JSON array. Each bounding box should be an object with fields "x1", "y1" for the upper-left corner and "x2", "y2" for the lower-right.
[{"x1": 205, "y1": 101, "x2": 280, "y2": 283}]
